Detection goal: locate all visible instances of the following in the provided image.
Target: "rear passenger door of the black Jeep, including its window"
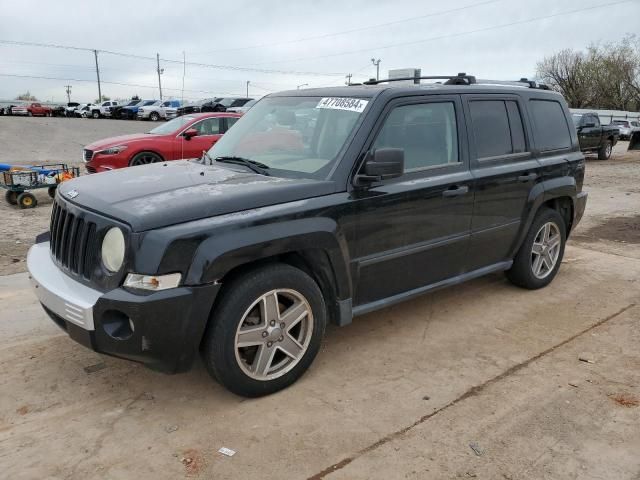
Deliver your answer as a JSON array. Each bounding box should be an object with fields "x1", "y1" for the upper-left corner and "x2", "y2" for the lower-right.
[{"x1": 464, "y1": 95, "x2": 540, "y2": 270}]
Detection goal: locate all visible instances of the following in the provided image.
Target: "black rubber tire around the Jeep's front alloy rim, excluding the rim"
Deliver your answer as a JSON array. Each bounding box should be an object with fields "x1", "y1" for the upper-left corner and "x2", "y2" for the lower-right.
[{"x1": 202, "y1": 264, "x2": 326, "y2": 397}]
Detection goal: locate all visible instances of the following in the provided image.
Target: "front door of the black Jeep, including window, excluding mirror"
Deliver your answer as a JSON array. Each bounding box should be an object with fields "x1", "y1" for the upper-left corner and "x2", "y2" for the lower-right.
[{"x1": 352, "y1": 96, "x2": 473, "y2": 307}]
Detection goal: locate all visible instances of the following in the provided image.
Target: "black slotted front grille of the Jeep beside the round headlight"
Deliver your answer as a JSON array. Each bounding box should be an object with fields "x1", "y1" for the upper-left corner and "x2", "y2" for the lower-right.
[{"x1": 49, "y1": 202, "x2": 99, "y2": 279}]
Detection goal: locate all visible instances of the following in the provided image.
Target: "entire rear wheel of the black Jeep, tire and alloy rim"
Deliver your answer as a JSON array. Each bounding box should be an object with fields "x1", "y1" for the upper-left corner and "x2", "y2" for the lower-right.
[{"x1": 507, "y1": 207, "x2": 567, "y2": 290}]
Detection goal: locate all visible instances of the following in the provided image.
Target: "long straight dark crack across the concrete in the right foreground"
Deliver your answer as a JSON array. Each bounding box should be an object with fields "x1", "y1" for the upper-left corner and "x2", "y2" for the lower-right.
[{"x1": 307, "y1": 303, "x2": 636, "y2": 480}]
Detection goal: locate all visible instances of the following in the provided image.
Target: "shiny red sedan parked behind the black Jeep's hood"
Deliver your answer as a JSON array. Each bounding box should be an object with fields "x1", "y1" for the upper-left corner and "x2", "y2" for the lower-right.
[{"x1": 83, "y1": 112, "x2": 241, "y2": 173}]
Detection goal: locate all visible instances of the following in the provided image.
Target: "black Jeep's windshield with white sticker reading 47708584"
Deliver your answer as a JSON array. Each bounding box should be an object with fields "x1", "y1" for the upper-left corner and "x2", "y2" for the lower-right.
[{"x1": 209, "y1": 97, "x2": 368, "y2": 179}]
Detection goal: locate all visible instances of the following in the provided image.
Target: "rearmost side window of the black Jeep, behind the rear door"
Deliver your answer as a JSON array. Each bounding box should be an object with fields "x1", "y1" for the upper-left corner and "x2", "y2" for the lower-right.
[{"x1": 530, "y1": 100, "x2": 571, "y2": 152}]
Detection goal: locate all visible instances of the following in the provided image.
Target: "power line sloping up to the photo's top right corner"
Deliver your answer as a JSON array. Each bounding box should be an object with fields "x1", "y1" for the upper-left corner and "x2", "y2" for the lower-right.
[{"x1": 253, "y1": 0, "x2": 636, "y2": 65}]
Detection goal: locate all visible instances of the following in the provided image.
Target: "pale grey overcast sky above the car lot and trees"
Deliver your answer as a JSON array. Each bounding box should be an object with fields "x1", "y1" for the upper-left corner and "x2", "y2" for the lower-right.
[{"x1": 0, "y1": 0, "x2": 640, "y2": 102}]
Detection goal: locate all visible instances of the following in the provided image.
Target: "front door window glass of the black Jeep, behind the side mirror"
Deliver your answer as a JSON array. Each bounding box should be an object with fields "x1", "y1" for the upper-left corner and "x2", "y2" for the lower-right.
[{"x1": 373, "y1": 102, "x2": 459, "y2": 172}]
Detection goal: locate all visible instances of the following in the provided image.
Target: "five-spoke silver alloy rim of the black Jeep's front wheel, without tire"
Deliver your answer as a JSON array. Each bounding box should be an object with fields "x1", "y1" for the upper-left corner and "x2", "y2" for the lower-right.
[{"x1": 234, "y1": 289, "x2": 313, "y2": 381}]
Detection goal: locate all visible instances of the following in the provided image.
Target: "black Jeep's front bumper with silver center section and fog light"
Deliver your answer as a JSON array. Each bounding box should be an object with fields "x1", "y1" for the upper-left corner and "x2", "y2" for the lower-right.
[{"x1": 27, "y1": 242, "x2": 220, "y2": 373}]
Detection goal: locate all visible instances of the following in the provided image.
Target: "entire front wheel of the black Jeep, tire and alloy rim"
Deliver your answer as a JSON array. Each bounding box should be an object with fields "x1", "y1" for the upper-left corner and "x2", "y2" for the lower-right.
[{"x1": 202, "y1": 264, "x2": 326, "y2": 397}]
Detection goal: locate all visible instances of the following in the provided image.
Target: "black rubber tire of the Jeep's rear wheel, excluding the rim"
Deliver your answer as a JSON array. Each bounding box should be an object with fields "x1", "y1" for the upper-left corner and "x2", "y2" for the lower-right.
[{"x1": 506, "y1": 207, "x2": 567, "y2": 290}]
